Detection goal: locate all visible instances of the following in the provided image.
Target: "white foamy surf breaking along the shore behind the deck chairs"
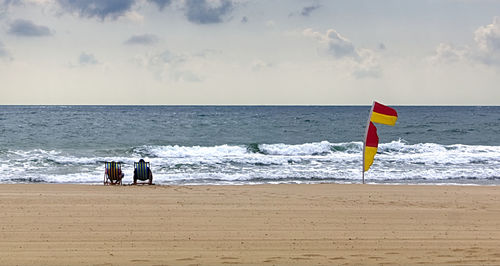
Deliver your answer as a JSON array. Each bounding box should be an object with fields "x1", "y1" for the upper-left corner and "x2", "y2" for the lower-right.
[{"x1": 0, "y1": 141, "x2": 500, "y2": 184}]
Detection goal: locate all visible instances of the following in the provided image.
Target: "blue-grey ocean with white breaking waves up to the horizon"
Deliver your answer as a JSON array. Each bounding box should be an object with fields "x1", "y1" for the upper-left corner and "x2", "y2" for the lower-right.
[{"x1": 0, "y1": 106, "x2": 500, "y2": 185}]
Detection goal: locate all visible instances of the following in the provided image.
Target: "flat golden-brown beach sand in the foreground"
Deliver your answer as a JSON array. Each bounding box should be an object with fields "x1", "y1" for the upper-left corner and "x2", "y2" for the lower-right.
[{"x1": 0, "y1": 184, "x2": 500, "y2": 265}]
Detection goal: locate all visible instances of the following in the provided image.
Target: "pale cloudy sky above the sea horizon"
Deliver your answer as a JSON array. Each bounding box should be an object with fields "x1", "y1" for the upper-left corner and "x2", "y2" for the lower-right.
[{"x1": 0, "y1": 0, "x2": 500, "y2": 105}]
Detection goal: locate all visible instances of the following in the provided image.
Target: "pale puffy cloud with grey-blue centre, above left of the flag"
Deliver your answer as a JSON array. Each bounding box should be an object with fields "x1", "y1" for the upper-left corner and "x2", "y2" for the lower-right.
[{"x1": 302, "y1": 29, "x2": 382, "y2": 78}]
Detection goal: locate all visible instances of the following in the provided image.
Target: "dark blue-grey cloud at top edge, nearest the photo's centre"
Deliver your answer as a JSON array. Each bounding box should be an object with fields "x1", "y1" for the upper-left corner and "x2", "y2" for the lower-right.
[{"x1": 184, "y1": 0, "x2": 234, "y2": 24}]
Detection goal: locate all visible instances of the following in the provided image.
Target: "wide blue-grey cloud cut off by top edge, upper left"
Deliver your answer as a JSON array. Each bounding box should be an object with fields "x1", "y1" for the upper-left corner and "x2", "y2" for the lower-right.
[{"x1": 57, "y1": 0, "x2": 135, "y2": 20}]
